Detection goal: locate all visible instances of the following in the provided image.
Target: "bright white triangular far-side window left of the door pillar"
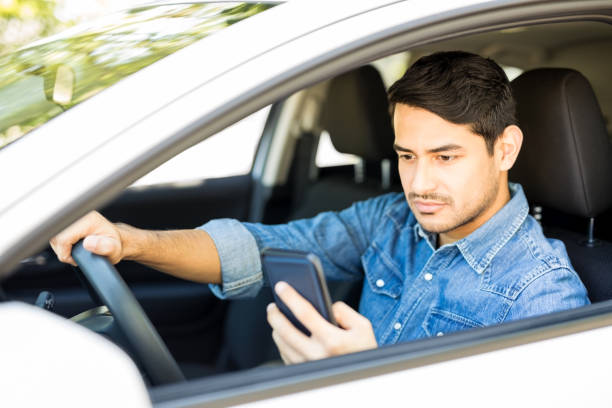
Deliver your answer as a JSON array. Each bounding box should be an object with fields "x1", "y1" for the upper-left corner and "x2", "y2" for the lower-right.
[{"x1": 132, "y1": 106, "x2": 270, "y2": 186}]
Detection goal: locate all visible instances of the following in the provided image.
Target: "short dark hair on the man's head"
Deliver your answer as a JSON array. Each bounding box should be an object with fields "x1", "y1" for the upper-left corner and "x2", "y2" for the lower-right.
[{"x1": 389, "y1": 51, "x2": 516, "y2": 154}]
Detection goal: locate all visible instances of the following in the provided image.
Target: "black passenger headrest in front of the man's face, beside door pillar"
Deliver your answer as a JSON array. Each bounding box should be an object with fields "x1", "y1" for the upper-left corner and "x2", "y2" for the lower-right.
[{"x1": 321, "y1": 65, "x2": 396, "y2": 161}]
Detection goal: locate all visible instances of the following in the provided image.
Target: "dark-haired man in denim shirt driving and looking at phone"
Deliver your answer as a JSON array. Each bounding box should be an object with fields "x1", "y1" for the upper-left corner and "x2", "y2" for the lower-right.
[{"x1": 51, "y1": 52, "x2": 589, "y2": 363}]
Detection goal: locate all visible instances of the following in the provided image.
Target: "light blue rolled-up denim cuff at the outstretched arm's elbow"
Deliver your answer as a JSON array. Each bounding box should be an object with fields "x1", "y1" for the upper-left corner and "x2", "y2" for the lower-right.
[{"x1": 199, "y1": 219, "x2": 263, "y2": 299}]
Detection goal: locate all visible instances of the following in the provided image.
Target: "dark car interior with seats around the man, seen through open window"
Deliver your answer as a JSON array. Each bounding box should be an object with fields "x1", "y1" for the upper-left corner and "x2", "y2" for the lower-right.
[{"x1": 2, "y1": 17, "x2": 612, "y2": 384}]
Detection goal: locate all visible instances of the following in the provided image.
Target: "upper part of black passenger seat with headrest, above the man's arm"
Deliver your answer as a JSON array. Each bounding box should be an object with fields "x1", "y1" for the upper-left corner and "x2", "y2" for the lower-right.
[{"x1": 289, "y1": 65, "x2": 399, "y2": 220}]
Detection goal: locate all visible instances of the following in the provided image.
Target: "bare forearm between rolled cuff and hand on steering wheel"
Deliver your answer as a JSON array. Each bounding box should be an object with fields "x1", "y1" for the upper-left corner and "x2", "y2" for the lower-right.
[{"x1": 116, "y1": 224, "x2": 221, "y2": 284}]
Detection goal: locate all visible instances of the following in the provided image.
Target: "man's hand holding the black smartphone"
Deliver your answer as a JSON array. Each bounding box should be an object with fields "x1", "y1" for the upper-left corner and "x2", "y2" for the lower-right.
[{"x1": 268, "y1": 282, "x2": 378, "y2": 364}]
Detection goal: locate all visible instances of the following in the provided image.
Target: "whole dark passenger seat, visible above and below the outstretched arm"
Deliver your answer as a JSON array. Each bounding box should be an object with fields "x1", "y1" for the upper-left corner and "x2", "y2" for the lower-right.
[{"x1": 221, "y1": 66, "x2": 397, "y2": 369}]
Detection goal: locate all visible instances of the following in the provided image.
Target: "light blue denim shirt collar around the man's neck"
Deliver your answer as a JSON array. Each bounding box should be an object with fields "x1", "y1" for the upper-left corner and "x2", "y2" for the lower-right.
[{"x1": 414, "y1": 183, "x2": 529, "y2": 274}]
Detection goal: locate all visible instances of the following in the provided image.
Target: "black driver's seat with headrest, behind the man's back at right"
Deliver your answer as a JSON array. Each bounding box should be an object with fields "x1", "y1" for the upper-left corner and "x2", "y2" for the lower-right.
[{"x1": 510, "y1": 68, "x2": 612, "y2": 302}]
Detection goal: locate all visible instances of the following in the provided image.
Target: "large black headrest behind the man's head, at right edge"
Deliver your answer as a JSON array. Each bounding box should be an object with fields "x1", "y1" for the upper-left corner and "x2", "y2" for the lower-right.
[{"x1": 510, "y1": 68, "x2": 612, "y2": 218}]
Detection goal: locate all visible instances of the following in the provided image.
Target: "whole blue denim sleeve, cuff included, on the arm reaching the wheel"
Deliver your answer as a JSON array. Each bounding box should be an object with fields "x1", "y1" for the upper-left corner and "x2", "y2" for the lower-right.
[{"x1": 200, "y1": 193, "x2": 403, "y2": 298}]
